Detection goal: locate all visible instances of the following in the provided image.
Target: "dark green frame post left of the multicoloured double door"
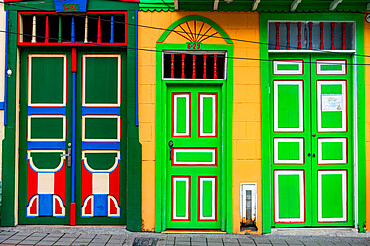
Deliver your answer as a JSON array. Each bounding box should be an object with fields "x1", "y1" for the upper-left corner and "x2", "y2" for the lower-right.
[{"x1": 1, "y1": 11, "x2": 18, "y2": 226}]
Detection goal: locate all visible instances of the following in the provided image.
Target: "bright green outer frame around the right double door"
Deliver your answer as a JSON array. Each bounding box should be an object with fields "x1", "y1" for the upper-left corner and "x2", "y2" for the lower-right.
[{"x1": 260, "y1": 13, "x2": 366, "y2": 233}]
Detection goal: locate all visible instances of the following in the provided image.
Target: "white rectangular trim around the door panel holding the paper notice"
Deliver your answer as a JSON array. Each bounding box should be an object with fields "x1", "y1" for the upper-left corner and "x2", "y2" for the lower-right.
[{"x1": 316, "y1": 80, "x2": 347, "y2": 132}]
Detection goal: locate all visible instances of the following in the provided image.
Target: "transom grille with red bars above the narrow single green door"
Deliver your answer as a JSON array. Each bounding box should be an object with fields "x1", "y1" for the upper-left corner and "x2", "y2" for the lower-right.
[{"x1": 163, "y1": 51, "x2": 226, "y2": 80}]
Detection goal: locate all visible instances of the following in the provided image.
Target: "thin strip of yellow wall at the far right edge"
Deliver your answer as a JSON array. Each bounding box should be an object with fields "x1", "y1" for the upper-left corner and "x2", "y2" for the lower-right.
[{"x1": 364, "y1": 21, "x2": 370, "y2": 230}]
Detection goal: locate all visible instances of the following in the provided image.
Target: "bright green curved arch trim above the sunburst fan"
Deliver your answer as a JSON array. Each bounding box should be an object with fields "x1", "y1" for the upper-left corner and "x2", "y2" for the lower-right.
[{"x1": 157, "y1": 15, "x2": 233, "y2": 44}]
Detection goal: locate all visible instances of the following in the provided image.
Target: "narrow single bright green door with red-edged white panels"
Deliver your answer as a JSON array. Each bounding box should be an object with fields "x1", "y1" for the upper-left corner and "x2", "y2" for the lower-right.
[{"x1": 166, "y1": 85, "x2": 222, "y2": 229}]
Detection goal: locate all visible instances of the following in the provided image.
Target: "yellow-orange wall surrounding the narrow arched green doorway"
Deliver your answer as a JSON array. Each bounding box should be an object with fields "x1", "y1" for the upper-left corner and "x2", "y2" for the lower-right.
[{"x1": 138, "y1": 11, "x2": 262, "y2": 233}]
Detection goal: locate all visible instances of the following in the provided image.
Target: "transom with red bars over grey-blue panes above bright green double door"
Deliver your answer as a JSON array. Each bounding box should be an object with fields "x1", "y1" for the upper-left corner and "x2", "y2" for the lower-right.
[{"x1": 269, "y1": 21, "x2": 355, "y2": 50}]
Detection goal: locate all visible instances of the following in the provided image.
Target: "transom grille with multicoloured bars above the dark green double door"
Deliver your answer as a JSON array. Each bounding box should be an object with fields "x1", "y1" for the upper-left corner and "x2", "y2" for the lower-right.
[{"x1": 18, "y1": 12, "x2": 127, "y2": 46}]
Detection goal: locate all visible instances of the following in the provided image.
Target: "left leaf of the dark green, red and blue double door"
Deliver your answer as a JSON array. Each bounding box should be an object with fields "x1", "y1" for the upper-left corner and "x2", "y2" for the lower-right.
[{"x1": 19, "y1": 51, "x2": 71, "y2": 224}]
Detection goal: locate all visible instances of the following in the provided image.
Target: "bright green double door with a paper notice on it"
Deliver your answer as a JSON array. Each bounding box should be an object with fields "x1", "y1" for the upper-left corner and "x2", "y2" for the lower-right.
[{"x1": 270, "y1": 54, "x2": 354, "y2": 227}]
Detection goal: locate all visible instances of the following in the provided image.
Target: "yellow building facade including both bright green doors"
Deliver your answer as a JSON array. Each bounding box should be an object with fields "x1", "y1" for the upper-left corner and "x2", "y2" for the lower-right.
[{"x1": 138, "y1": 0, "x2": 369, "y2": 233}]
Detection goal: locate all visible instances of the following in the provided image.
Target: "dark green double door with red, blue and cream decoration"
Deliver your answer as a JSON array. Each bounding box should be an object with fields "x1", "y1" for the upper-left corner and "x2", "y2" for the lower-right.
[{"x1": 18, "y1": 48, "x2": 126, "y2": 224}]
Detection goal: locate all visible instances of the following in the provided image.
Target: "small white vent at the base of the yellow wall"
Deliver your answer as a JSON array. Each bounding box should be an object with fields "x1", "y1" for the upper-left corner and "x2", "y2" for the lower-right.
[{"x1": 240, "y1": 183, "x2": 257, "y2": 227}]
